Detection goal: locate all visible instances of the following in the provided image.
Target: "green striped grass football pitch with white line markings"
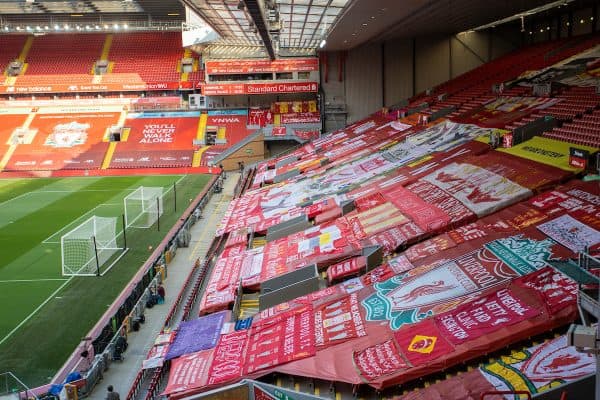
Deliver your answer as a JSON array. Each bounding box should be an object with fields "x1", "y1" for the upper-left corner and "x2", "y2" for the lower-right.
[{"x1": 0, "y1": 175, "x2": 210, "y2": 387}]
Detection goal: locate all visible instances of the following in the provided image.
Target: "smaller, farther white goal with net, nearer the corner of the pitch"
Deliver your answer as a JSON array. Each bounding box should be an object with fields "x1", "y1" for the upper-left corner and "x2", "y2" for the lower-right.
[{"x1": 123, "y1": 186, "x2": 163, "y2": 228}]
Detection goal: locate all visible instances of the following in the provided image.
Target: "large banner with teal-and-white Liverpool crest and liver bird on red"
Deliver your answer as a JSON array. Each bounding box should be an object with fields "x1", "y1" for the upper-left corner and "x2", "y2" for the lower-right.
[{"x1": 362, "y1": 236, "x2": 555, "y2": 330}]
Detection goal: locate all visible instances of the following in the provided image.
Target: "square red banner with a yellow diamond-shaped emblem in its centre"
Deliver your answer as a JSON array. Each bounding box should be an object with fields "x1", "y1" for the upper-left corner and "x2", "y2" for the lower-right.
[{"x1": 394, "y1": 318, "x2": 454, "y2": 366}]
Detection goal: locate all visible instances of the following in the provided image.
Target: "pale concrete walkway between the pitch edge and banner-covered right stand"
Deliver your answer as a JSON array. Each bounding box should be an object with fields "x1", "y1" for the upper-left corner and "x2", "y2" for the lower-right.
[{"x1": 88, "y1": 173, "x2": 239, "y2": 400}]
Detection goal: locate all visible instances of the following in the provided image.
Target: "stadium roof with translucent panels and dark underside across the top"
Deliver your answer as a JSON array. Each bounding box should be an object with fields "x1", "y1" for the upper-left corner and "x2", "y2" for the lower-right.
[{"x1": 0, "y1": 0, "x2": 593, "y2": 54}]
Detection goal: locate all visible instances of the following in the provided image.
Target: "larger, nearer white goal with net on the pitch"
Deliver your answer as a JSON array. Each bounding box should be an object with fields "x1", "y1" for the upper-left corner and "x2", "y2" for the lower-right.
[{"x1": 60, "y1": 215, "x2": 124, "y2": 276}]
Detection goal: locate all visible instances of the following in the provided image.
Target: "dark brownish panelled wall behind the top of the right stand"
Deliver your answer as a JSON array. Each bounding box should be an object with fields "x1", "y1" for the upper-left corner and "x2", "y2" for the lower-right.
[{"x1": 321, "y1": 28, "x2": 521, "y2": 123}]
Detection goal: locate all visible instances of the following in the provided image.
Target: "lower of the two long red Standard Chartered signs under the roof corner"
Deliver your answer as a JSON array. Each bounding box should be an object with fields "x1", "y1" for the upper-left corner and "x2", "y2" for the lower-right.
[{"x1": 200, "y1": 82, "x2": 319, "y2": 96}]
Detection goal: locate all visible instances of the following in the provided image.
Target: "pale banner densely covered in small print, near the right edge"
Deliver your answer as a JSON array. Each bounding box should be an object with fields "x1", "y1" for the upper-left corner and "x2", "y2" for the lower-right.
[{"x1": 537, "y1": 215, "x2": 600, "y2": 253}]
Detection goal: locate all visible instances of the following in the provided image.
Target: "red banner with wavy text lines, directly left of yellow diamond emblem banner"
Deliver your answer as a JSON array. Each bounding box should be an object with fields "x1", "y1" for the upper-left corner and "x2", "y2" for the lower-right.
[{"x1": 352, "y1": 339, "x2": 409, "y2": 382}]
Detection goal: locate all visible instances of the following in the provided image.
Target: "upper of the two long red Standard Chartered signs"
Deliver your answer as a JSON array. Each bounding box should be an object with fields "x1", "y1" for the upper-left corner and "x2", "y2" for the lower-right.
[{"x1": 204, "y1": 58, "x2": 319, "y2": 75}]
